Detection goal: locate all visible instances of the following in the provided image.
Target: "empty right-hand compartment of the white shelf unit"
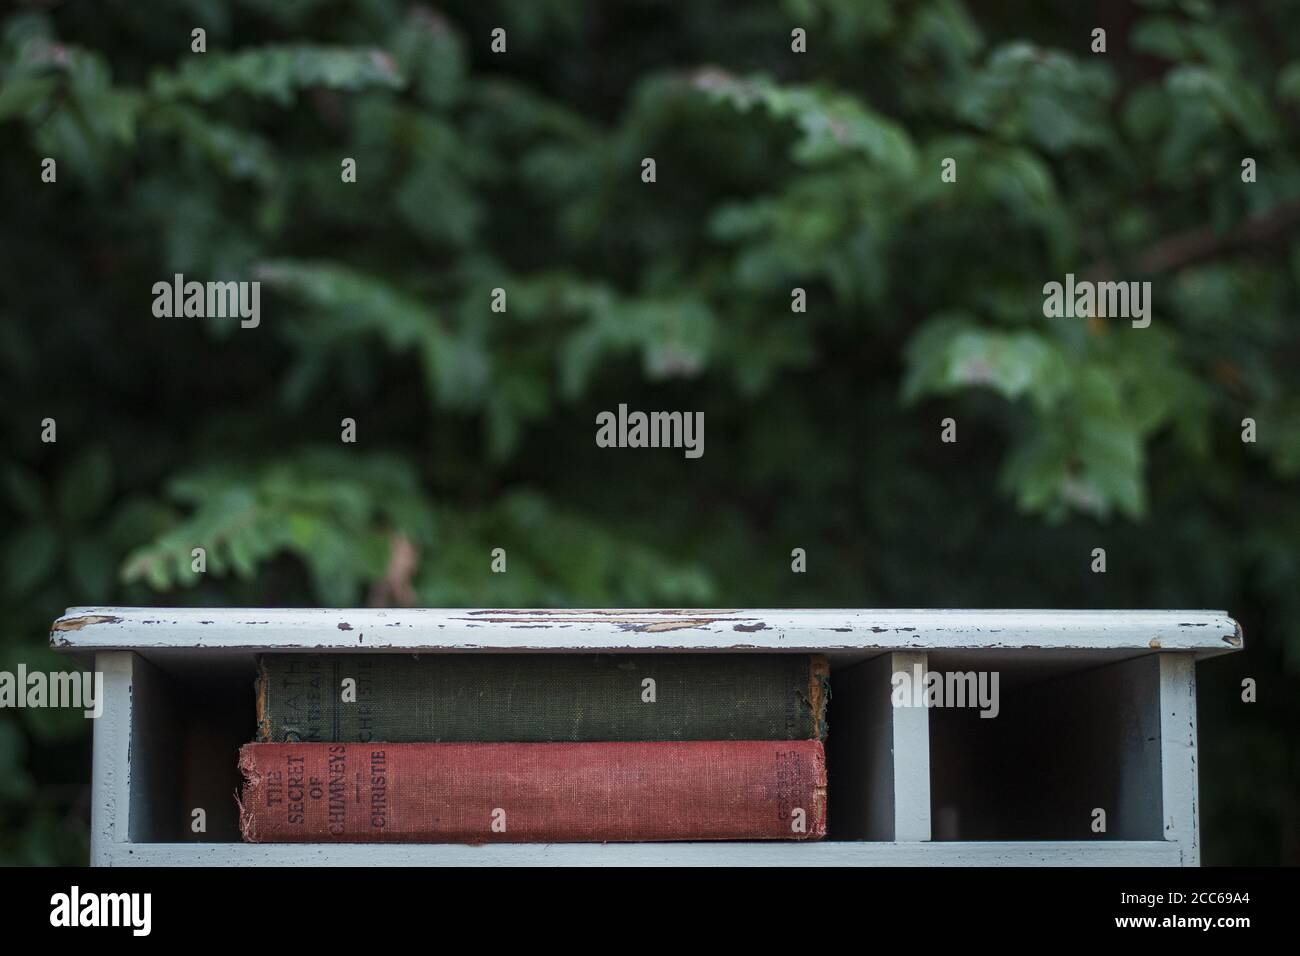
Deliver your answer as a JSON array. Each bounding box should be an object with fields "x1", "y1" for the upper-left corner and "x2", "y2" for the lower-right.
[{"x1": 930, "y1": 652, "x2": 1197, "y2": 861}]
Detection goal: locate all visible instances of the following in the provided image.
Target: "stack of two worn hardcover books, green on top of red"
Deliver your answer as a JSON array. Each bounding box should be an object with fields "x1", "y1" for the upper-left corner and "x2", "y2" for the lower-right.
[{"x1": 239, "y1": 654, "x2": 828, "y2": 843}]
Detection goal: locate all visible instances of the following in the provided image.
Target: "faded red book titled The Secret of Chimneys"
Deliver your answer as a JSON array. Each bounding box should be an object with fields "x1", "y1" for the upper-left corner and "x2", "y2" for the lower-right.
[{"x1": 239, "y1": 740, "x2": 826, "y2": 843}]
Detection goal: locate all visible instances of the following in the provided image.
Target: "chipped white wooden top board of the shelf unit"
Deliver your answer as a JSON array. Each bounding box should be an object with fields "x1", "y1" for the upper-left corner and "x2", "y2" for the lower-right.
[{"x1": 49, "y1": 607, "x2": 1243, "y2": 657}]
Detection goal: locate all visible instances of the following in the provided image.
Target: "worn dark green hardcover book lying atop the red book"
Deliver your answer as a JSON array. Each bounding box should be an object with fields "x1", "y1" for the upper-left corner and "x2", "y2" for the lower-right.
[{"x1": 257, "y1": 654, "x2": 828, "y2": 743}]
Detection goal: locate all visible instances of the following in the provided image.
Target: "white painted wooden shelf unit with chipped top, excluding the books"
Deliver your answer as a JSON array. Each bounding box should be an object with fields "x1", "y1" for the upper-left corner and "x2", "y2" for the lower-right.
[{"x1": 51, "y1": 607, "x2": 1243, "y2": 866}]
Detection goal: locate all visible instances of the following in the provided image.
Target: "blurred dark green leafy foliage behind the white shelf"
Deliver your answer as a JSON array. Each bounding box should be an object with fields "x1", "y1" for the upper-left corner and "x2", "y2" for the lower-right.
[{"x1": 0, "y1": 0, "x2": 1300, "y2": 862}]
